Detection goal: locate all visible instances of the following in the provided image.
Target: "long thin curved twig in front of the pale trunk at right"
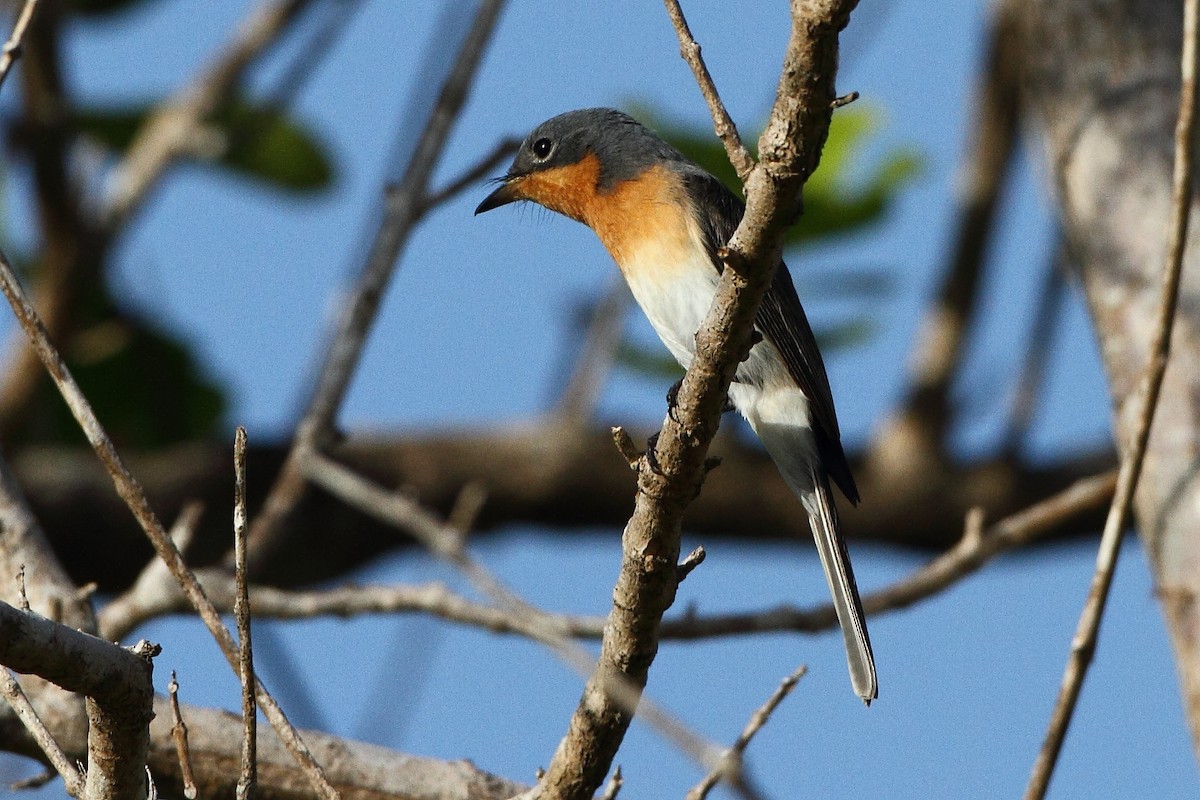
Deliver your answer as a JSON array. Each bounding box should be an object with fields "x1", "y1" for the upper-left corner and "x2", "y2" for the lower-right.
[{"x1": 1025, "y1": 0, "x2": 1200, "y2": 800}]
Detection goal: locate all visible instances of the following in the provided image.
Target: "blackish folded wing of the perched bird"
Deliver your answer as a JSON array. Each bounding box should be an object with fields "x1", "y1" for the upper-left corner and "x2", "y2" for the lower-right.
[{"x1": 684, "y1": 167, "x2": 858, "y2": 504}]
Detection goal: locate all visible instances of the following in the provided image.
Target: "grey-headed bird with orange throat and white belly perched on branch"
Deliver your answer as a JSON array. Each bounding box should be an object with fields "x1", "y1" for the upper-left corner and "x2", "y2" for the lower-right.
[{"x1": 475, "y1": 108, "x2": 878, "y2": 705}]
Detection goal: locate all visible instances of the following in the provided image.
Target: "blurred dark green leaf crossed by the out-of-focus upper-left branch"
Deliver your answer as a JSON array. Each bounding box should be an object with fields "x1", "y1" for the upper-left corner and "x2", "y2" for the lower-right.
[{"x1": 74, "y1": 100, "x2": 334, "y2": 192}]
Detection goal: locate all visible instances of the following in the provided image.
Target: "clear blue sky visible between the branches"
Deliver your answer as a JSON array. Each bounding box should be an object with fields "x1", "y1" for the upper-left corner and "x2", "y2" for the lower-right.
[{"x1": 6, "y1": 0, "x2": 1196, "y2": 798}]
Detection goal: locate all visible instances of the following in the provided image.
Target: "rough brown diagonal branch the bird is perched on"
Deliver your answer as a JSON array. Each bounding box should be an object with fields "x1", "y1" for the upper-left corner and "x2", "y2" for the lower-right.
[{"x1": 536, "y1": 0, "x2": 856, "y2": 799}]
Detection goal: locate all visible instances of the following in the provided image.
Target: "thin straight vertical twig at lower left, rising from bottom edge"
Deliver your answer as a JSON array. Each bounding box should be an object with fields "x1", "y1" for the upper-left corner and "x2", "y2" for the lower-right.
[{"x1": 233, "y1": 425, "x2": 258, "y2": 800}]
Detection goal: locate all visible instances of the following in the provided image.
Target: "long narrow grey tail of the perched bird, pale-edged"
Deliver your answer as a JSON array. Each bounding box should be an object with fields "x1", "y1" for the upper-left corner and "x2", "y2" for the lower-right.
[{"x1": 800, "y1": 468, "x2": 880, "y2": 705}]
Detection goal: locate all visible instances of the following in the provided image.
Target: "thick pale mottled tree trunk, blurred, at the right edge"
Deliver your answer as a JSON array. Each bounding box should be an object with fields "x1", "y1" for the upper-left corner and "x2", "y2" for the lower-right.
[{"x1": 1020, "y1": 0, "x2": 1200, "y2": 750}]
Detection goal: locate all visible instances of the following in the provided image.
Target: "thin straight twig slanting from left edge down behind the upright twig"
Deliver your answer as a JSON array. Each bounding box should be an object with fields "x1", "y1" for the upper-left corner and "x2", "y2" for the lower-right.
[{"x1": 0, "y1": 245, "x2": 337, "y2": 800}]
